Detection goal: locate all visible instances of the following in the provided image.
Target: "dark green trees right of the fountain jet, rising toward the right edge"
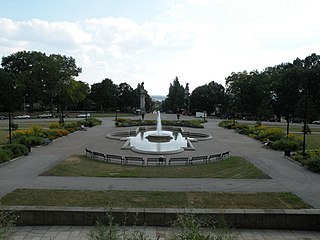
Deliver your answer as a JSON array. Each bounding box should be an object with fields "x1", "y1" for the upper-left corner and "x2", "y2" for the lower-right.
[{"x1": 163, "y1": 53, "x2": 320, "y2": 122}]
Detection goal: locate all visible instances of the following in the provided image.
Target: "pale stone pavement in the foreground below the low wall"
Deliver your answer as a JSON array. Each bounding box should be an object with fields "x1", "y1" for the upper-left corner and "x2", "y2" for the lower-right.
[{"x1": 13, "y1": 226, "x2": 320, "y2": 240}]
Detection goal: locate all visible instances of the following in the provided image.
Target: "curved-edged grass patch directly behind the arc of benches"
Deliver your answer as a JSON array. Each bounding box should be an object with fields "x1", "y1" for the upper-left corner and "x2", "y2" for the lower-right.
[{"x1": 42, "y1": 155, "x2": 269, "y2": 179}]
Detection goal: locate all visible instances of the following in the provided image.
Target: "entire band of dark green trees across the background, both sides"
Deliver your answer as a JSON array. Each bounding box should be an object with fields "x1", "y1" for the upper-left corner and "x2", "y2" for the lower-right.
[{"x1": 0, "y1": 51, "x2": 320, "y2": 121}]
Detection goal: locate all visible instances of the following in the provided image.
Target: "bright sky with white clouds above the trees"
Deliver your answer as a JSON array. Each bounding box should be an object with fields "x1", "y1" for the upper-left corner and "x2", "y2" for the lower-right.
[{"x1": 0, "y1": 0, "x2": 320, "y2": 95}]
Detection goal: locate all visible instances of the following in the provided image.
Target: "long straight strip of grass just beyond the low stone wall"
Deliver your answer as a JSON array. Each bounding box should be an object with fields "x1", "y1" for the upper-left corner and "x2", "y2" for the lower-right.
[{"x1": 1, "y1": 189, "x2": 312, "y2": 209}]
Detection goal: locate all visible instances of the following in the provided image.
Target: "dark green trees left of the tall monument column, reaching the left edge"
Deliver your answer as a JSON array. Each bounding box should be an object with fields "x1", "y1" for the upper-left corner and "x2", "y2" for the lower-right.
[{"x1": 0, "y1": 51, "x2": 152, "y2": 112}]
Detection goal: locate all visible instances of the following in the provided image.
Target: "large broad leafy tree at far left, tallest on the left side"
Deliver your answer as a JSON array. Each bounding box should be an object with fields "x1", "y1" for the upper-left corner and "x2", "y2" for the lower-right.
[{"x1": 1, "y1": 51, "x2": 81, "y2": 110}]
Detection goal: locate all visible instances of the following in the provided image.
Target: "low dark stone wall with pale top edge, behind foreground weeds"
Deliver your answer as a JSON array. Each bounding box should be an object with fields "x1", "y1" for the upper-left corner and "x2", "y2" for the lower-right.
[{"x1": 6, "y1": 207, "x2": 320, "y2": 230}]
